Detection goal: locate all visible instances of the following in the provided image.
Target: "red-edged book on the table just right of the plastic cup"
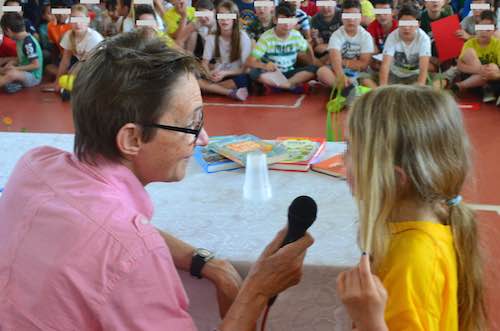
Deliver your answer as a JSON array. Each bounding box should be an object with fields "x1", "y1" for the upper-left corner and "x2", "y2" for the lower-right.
[{"x1": 269, "y1": 137, "x2": 326, "y2": 172}]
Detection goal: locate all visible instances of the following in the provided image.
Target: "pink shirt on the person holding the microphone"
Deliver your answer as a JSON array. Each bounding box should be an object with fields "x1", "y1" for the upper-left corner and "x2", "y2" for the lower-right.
[{"x1": 0, "y1": 147, "x2": 196, "y2": 331}]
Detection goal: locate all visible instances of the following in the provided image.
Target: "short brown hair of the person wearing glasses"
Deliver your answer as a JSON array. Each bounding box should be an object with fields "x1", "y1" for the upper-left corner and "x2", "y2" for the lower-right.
[{"x1": 71, "y1": 32, "x2": 199, "y2": 163}]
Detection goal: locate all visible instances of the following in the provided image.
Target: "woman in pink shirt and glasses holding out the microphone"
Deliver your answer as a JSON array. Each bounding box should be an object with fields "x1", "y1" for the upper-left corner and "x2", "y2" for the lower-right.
[{"x1": 0, "y1": 32, "x2": 313, "y2": 331}]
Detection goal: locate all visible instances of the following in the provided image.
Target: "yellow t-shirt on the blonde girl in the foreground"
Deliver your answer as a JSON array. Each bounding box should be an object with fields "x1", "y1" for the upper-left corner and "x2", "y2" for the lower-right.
[{"x1": 378, "y1": 221, "x2": 458, "y2": 331}]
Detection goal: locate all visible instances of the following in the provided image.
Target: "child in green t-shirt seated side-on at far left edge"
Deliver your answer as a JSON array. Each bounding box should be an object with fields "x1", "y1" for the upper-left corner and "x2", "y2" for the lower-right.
[{"x1": 0, "y1": 13, "x2": 43, "y2": 93}]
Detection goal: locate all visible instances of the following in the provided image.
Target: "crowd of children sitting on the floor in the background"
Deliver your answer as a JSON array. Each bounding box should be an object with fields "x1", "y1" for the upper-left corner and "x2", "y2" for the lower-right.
[{"x1": 0, "y1": 0, "x2": 500, "y2": 105}]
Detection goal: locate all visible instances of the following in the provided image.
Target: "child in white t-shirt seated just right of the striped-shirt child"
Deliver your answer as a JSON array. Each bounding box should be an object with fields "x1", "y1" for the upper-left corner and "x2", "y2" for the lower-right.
[{"x1": 318, "y1": 0, "x2": 375, "y2": 87}]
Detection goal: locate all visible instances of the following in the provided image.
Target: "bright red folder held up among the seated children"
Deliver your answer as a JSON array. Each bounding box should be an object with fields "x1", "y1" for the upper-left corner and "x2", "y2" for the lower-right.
[{"x1": 431, "y1": 15, "x2": 464, "y2": 62}]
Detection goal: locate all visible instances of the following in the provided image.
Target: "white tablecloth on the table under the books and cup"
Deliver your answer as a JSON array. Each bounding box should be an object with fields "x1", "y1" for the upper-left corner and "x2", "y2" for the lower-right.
[{"x1": 0, "y1": 133, "x2": 360, "y2": 331}]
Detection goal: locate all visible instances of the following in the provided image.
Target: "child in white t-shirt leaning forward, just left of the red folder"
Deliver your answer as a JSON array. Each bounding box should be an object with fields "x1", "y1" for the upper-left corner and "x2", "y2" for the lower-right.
[{"x1": 379, "y1": 5, "x2": 431, "y2": 86}]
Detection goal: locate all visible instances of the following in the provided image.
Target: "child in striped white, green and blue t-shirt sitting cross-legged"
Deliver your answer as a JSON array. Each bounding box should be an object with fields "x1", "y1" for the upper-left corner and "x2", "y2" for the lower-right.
[{"x1": 247, "y1": 2, "x2": 318, "y2": 93}]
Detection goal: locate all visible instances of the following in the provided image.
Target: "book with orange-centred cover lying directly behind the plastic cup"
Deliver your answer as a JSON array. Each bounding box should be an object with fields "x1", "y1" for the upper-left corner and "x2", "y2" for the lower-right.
[{"x1": 208, "y1": 134, "x2": 287, "y2": 166}]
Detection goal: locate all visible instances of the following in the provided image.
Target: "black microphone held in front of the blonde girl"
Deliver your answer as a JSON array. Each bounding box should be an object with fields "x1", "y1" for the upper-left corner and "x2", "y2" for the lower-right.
[{"x1": 267, "y1": 195, "x2": 318, "y2": 307}]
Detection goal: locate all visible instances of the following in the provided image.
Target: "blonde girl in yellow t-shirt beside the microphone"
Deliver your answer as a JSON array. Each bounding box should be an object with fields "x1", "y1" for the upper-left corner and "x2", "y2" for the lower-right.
[{"x1": 337, "y1": 85, "x2": 485, "y2": 331}]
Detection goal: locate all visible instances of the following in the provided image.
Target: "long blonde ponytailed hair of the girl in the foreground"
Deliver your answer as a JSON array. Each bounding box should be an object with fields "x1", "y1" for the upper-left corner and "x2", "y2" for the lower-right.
[{"x1": 348, "y1": 85, "x2": 486, "y2": 331}]
